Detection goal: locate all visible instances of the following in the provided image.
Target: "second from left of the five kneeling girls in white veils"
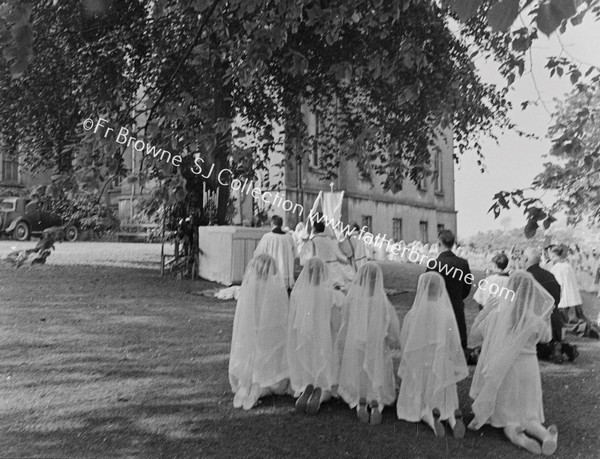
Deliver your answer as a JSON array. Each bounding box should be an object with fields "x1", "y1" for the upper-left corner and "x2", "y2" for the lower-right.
[{"x1": 287, "y1": 258, "x2": 344, "y2": 414}]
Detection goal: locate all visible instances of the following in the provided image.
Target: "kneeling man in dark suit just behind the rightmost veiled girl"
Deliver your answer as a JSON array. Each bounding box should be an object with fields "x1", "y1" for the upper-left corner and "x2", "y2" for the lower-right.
[{"x1": 522, "y1": 247, "x2": 579, "y2": 364}]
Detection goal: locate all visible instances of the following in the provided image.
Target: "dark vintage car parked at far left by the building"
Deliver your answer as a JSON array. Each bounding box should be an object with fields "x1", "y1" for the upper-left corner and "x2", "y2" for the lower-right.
[{"x1": 0, "y1": 197, "x2": 79, "y2": 241}]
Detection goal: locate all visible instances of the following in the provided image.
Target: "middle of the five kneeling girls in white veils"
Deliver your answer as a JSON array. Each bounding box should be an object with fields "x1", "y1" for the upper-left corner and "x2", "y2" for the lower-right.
[{"x1": 336, "y1": 262, "x2": 400, "y2": 424}]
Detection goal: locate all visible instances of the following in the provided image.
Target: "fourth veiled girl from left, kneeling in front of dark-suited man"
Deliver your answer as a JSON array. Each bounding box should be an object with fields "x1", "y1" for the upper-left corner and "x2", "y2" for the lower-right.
[{"x1": 397, "y1": 272, "x2": 469, "y2": 438}]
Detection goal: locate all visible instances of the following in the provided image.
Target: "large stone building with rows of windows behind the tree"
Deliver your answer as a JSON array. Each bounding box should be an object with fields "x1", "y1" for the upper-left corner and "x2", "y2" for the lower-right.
[{"x1": 0, "y1": 103, "x2": 456, "y2": 243}]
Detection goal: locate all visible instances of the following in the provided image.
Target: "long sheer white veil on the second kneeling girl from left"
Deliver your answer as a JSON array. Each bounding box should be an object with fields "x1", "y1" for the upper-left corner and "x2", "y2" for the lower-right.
[{"x1": 287, "y1": 258, "x2": 334, "y2": 390}]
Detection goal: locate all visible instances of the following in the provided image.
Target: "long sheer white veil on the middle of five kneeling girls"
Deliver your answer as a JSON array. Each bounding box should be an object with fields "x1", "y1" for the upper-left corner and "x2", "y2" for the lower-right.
[{"x1": 337, "y1": 262, "x2": 392, "y2": 407}]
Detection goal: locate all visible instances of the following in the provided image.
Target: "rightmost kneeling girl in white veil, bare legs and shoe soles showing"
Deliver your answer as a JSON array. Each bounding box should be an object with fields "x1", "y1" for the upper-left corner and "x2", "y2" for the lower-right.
[{"x1": 469, "y1": 271, "x2": 558, "y2": 455}]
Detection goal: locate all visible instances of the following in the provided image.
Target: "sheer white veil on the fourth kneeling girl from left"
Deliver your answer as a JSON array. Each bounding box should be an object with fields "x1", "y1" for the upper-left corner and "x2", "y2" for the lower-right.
[{"x1": 398, "y1": 272, "x2": 469, "y2": 404}]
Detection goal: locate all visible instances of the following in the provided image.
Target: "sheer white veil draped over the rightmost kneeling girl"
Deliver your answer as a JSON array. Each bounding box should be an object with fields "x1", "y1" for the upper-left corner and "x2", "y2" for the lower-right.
[{"x1": 470, "y1": 271, "x2": 554, "y2": 428}]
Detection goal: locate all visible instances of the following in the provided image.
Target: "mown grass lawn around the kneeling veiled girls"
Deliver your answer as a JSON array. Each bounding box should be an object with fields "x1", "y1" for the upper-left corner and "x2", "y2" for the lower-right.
[{"x1": 0, "y1": 263, "x2": 600, "y2": 458}]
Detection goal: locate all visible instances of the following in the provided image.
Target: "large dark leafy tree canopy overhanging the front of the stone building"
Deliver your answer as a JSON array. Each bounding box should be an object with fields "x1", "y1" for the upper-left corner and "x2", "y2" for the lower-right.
[{"x1": 0, "y1": 0, "x2": 507, "y2": 223}]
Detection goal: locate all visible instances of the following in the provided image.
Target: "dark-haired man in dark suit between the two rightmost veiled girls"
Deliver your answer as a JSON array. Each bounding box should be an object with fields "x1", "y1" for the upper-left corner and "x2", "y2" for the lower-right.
[{"x1": 427, "y1": 230, "x2": 474, "y2": 352}]
